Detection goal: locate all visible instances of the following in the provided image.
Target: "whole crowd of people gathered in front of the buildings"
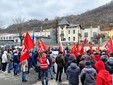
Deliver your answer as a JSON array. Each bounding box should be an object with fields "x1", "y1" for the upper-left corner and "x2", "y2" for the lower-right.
[{"x1": 0, "y1": 48, "x2": 113, "y2": 85}]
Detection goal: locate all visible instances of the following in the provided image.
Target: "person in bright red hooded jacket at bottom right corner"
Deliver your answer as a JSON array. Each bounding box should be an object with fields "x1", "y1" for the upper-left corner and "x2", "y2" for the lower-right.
[{"x1": 95, "y1": 61, "x2": 112, "y2": 85}]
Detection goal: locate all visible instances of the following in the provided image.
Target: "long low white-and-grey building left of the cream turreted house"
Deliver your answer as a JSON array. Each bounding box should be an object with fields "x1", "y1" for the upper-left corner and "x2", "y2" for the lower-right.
[{"x1": 0, "y1": 29, "x2": 56, "y2": 45}]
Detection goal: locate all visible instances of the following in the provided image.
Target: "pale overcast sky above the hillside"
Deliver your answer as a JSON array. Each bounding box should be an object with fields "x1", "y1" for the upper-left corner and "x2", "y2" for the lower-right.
[{"x1": 0, "y1": 0, "x2": 111, "y2": 27}]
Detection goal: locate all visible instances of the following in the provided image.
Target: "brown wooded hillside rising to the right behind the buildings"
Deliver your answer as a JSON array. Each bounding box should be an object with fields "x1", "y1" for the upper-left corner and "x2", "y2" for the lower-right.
[{"x1": 1, "y1": 1, "x2": 113, "y2": 33}]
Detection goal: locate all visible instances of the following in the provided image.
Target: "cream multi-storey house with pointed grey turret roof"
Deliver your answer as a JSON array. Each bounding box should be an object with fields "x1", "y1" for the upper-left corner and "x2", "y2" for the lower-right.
[{"x1": 57, "y1": 18, "x2": 81, "y2": 42}]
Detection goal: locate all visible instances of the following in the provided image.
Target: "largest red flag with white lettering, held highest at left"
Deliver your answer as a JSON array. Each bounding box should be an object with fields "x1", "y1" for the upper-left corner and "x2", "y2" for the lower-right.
[{"x1": 20, "y1": 32, "x2": 35, "y2": 62}]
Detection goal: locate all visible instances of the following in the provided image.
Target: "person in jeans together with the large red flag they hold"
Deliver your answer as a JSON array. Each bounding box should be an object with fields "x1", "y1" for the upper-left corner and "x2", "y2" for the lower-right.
[{"x1": 20, "y1": 32, "x2": 35, "y2": 82}]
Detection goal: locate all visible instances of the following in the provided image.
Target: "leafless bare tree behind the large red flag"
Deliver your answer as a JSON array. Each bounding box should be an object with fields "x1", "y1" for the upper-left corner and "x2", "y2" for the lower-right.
[{"x1": 12, "y1": 17, "x2": 25, "y2": 46}]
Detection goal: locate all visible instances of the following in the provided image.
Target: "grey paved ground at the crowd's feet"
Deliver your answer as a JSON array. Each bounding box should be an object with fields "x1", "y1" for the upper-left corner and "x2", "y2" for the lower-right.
[{"x1": 0, "y1": 69, "x2": 68, "y2": 85}]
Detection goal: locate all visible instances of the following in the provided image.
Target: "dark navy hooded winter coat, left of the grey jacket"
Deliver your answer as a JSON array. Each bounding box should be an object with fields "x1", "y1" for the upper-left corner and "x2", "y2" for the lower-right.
[{"x1": 67, "y1": 63, "x2": 80, "y2": 85}]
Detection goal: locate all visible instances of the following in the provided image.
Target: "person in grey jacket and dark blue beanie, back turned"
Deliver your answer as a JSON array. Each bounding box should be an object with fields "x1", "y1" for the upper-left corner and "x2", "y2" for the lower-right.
[{"x1": 80, "y1": 61, "x2": 97, "y2": 85}]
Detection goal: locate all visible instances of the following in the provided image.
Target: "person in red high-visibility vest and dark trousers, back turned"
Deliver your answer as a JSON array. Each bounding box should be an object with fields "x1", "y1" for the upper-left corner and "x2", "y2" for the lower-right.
[{"x1": 39, "y1": 53, "x2": 49, "y2": 85}]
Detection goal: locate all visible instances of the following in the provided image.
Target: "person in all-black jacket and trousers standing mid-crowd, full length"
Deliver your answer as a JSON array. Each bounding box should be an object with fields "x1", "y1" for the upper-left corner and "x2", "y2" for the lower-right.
[{"x1": 56, "y1": 52, "x2": 65, "y2": 82}]
